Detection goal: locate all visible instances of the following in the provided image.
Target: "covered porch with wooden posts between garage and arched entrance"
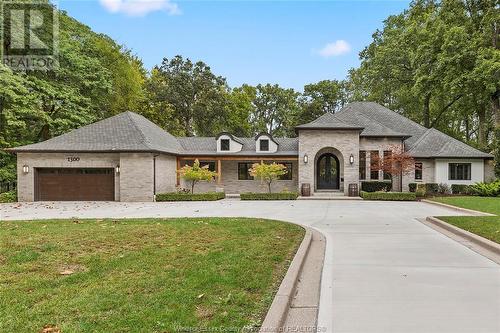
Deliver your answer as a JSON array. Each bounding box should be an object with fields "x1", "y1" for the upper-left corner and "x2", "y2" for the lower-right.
[{"x1": 177, "y1": 155, "x2": 298, "y2": 194}]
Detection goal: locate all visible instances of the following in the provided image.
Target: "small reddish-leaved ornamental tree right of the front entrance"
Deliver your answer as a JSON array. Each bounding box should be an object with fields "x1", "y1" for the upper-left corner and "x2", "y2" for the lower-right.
[{"x1": 370, "y1": 145, "x2": 415, "y2": 189}]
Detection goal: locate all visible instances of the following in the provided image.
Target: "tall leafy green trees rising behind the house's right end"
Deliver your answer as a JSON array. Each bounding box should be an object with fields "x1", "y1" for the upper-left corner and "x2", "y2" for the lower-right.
[{"x1": 347, "y1": 0, "x2": 500, "y2": 165}]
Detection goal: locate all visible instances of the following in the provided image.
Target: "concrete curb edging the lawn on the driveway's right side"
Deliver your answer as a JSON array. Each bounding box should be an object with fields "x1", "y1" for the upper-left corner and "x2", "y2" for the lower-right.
[{"x1": 424, "y1": 216, "x2": 500, "y2": 264}]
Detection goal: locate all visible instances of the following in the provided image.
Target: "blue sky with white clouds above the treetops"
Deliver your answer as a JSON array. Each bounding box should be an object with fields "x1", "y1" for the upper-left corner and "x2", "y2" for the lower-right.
[{"x1": 59, "y1": 0, "x2": 409, "y2": 91}]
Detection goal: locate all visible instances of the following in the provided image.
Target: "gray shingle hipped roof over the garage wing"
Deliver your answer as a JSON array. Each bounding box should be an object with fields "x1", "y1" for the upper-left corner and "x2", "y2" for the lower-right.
[{"x1": 8, "y1": 112, "x2": 181, "y2": 154}]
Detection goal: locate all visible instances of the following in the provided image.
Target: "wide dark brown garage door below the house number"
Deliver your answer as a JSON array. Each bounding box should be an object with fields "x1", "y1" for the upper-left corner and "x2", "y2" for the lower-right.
[{"x1": 35, "y1": 168, "x2": 115, "y2": 201}]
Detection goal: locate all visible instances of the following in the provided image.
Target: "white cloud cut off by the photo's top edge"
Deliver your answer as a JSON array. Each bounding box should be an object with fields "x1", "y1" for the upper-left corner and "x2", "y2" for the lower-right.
[{"x1": 99, "y1": 0, "x2": 181, "y2": 16}]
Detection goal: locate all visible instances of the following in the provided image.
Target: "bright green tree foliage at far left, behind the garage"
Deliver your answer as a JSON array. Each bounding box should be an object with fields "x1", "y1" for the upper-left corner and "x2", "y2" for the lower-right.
[{"x1": 0, "y1": 5, "x2": 145, "y2": 181}]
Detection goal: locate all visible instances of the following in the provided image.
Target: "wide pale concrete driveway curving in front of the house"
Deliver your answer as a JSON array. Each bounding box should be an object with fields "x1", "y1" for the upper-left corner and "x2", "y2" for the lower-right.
[{"x1": 0, "y1": 200, "x2": 500, "y2": 333}]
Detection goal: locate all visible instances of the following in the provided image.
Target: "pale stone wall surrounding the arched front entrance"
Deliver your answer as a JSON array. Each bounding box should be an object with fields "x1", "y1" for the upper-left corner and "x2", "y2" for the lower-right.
[{"x1": 298, "y1": 130, "x2": 359, "y2": 194}]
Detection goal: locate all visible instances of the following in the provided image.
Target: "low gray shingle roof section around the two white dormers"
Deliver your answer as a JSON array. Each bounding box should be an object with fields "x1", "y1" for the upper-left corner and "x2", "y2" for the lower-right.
[{"x1": 177, "y1": 137, "x2": 299, "y2": 156}]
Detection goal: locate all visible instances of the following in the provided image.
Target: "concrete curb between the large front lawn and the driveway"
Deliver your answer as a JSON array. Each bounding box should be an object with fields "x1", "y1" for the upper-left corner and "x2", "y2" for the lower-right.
[{"x1": 259, "y1": 227, "x2": 324, "y2": 333}]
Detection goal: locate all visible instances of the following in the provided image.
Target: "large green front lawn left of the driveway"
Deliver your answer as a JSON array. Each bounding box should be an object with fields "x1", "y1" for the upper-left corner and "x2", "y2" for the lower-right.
[{"x1": 0, "y1": 218, "x2": 304, "y2": 332}]
